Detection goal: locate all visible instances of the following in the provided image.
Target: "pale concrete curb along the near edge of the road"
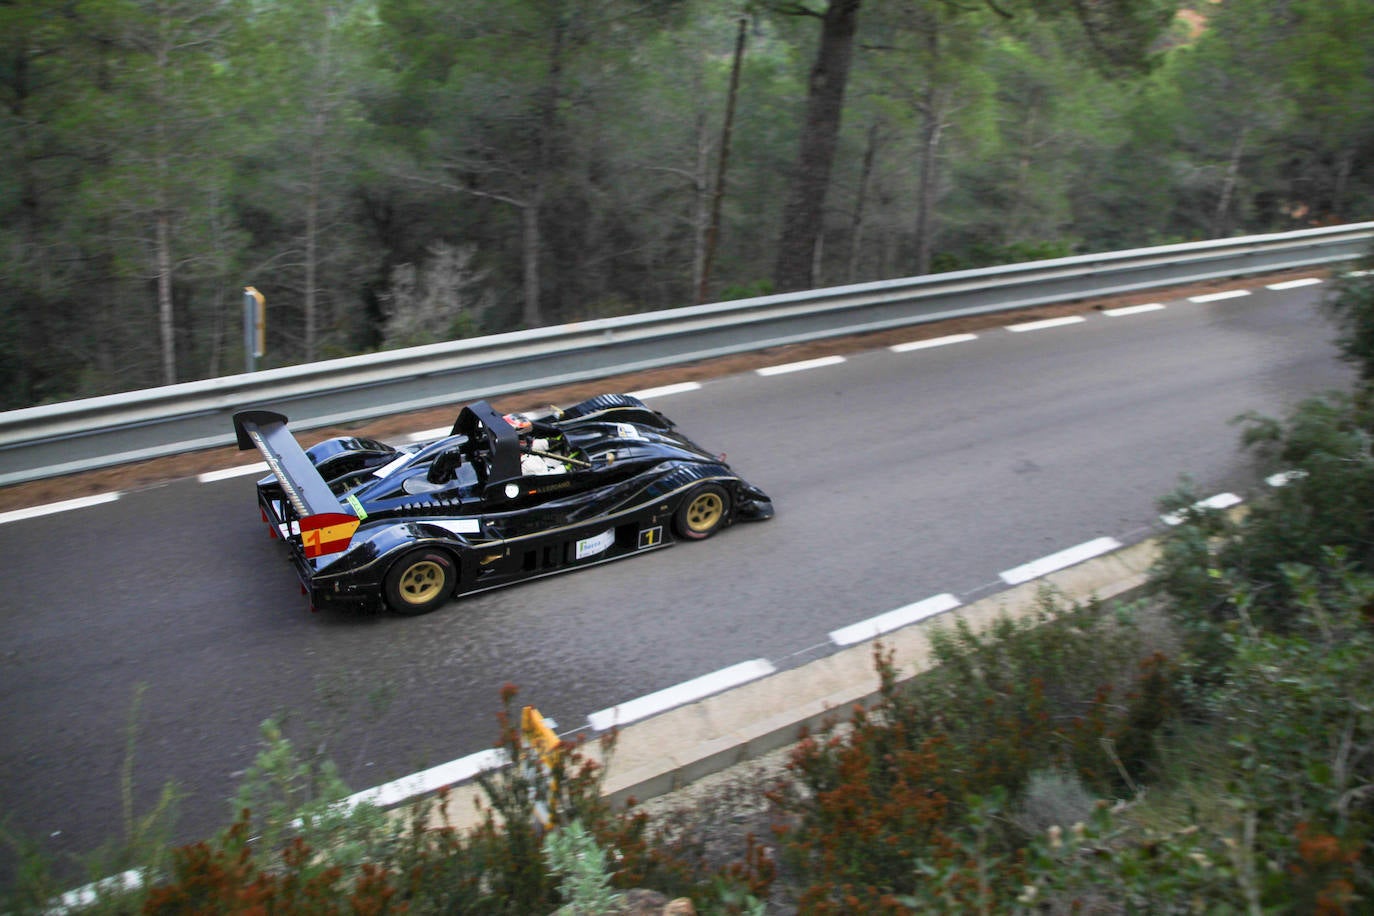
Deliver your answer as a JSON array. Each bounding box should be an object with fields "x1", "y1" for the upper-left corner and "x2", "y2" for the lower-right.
[{"x1": 428, "y1": 540, "x2": 1158, "y2": 828}]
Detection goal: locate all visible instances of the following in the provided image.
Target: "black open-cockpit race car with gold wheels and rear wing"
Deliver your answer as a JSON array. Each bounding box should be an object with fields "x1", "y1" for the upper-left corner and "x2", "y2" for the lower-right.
[{"x1": 234, "y1": 394, "x2": 774, "y2": 614}]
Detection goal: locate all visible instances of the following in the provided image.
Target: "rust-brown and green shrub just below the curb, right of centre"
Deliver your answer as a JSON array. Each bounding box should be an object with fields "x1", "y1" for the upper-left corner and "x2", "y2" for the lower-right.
[{"x1": 776, "y1": 596, "x2": 1173, "y2": 913}]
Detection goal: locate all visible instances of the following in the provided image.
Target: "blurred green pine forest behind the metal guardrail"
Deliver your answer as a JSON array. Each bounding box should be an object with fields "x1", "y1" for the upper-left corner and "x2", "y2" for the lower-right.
[{"x1": 0, "y1": 0, "x2": 1374, "y2": 409}]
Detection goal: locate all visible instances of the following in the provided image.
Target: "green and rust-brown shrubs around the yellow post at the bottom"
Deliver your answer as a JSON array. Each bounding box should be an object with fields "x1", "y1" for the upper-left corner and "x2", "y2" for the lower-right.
[{"x1": 104, "y1": 689, "x2": 772, "y2": 916}]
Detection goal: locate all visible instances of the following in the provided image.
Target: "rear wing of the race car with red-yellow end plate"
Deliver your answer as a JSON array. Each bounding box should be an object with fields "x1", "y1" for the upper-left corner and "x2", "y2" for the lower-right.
[{"x1": 234, "y1": 411, "x2": 361, "y2": 559}]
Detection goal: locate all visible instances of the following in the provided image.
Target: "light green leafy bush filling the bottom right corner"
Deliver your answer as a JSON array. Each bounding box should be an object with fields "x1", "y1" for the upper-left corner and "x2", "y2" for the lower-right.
[{"x1": 1021, "y1": 558, "x2": 1374, "y2": 913}]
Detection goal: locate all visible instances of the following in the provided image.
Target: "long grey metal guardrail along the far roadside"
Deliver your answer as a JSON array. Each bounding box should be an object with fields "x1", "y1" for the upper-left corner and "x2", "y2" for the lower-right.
[{"x1": 0, "y1": 222, "x2": 1374, "y2": 486}]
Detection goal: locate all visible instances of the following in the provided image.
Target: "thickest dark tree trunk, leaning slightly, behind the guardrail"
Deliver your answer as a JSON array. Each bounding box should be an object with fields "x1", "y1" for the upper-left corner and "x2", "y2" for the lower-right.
[{"x1": 774, "y1": 0, "x2": 861, "y2": 293}]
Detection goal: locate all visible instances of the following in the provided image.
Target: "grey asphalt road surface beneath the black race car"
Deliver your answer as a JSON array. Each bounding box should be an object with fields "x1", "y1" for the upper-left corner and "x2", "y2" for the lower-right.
[{"x1": 0, "y1": 287, "x2": 1351, "y2": 883}]
